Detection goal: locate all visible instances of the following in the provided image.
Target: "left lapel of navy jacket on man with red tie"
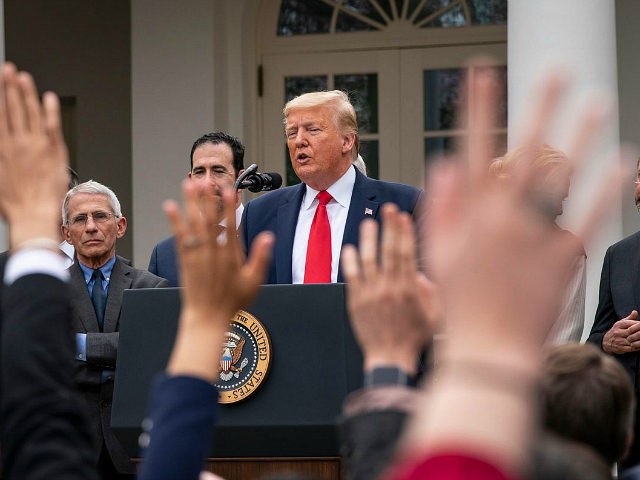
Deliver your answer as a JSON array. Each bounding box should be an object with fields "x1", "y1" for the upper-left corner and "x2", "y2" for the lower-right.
[{"x1": 274, "y1": 183, "x2": 306, "y2": 283}]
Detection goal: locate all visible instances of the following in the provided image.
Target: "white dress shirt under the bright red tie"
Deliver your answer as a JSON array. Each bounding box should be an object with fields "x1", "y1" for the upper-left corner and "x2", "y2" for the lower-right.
[{"x1": 291, "y1": 167, "x2": 356, "y2": 283}]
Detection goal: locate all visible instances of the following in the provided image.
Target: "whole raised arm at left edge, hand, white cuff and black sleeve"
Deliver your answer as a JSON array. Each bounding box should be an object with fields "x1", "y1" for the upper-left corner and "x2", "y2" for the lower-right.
[{"x1": 0, "y1": 63, "x2": 98, "y2": 480}]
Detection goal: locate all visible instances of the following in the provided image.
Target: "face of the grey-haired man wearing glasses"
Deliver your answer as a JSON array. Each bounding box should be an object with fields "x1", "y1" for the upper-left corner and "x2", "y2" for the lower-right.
[{"x1": 62, "y1": 193, "x2": 127, "y2": 268}]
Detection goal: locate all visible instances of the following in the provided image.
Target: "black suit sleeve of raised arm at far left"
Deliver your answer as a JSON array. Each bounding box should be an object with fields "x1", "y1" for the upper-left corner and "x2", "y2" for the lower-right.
[{"x1": 1, "y1": 275, "x2": 98, "y2": 480}]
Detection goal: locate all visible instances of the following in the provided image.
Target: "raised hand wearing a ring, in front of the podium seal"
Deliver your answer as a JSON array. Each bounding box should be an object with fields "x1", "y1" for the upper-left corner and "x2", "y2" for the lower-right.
[{"x1": 164, "y1": 181, "x2": 274, "y2": 381}]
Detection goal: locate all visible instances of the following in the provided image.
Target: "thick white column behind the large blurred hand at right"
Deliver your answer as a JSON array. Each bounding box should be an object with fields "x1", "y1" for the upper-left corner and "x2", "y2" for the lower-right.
[{"x1": 508, "y1": 0, "x2": 616, "y2": 338}]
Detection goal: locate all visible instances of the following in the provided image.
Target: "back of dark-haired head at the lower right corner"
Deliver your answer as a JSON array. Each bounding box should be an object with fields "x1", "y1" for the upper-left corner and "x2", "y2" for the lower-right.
[{"x1": 542, "y1": 343, "x2": 634, "y2": 464}]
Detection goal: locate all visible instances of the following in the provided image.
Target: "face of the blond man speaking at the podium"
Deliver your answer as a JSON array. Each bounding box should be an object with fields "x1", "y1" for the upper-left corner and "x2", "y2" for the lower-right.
[{"x1": 285, "y1": 106, "x2": 355, "y2": 190}]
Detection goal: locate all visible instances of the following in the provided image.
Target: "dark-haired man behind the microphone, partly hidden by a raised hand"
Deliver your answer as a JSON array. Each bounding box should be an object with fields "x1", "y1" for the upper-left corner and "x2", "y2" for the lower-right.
[{"x1": 149, "y1": 132, "x2": 244, "y2": 287}]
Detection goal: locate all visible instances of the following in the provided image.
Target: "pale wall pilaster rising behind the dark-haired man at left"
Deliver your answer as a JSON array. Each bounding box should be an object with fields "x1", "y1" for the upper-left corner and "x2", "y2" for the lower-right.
[{"x1": 131, "y1": 0, "x2": 215, "y2": 268}]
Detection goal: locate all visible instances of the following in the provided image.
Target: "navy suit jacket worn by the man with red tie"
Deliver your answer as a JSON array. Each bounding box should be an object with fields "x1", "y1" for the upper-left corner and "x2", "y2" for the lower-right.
[{"x1": 241, "y1": 167, "x2": 421, "y2": 283}]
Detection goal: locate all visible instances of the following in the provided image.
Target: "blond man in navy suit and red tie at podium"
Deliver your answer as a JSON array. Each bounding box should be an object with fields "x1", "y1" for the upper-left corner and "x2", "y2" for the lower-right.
[{"x1": 242, "y1": 90, "x2": 420, "y2": 283}]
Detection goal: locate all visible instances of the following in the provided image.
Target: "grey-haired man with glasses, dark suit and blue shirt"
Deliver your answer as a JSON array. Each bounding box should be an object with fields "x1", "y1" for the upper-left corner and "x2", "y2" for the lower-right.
[{"x1": 62, "y1": 181, "x2": 168, "y2": 478}]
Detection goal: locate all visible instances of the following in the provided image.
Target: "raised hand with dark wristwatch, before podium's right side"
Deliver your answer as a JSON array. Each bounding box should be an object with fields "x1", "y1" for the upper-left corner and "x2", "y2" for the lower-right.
[{"x1": 342, "y1": 204, "x2": 439, "y2": 374}]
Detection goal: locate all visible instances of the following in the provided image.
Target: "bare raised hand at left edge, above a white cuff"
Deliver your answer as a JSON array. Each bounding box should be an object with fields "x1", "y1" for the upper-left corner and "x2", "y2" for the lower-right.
[{"x1": 0, "y1": 63, "x2": 68, "y2": 248}]
